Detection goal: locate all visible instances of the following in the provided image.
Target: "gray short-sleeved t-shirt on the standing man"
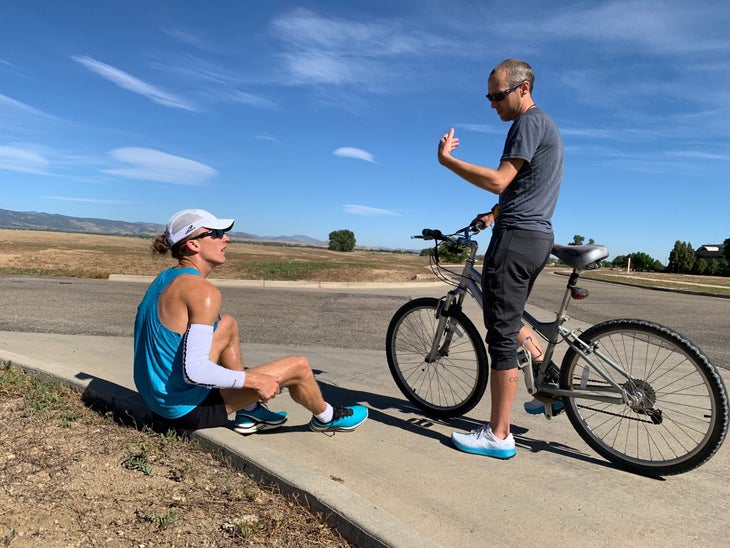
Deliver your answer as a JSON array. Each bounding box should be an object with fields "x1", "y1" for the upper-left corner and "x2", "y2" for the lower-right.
[{"x1": 496, "y1": 107, "x2": 563, "y2": 233}]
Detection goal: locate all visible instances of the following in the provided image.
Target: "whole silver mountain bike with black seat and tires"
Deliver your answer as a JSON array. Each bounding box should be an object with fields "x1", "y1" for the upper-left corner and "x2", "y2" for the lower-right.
[{"x1": 386, "y1": 223, "x2": 728, "y2": 476}]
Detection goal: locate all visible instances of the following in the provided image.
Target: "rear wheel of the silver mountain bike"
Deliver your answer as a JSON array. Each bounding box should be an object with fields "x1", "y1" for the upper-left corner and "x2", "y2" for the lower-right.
[{"x1": 560, "y1": 319, "x2": 728, "y2": 476}]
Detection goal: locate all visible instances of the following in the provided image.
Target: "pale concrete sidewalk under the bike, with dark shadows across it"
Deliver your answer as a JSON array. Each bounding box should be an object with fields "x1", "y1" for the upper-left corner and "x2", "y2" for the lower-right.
[{"x1": 0, "y1": 324, "x2": 730, "y2": 547}]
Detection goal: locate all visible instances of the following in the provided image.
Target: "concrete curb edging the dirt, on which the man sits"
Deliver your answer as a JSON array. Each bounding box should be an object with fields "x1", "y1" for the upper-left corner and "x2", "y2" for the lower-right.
[{"x1": 0, "y1": 348, "x2": 436, "y2": 548}]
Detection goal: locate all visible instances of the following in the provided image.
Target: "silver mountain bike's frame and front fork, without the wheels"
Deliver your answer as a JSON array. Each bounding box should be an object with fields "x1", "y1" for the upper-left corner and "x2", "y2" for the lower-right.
[{"x1": 426, "y1": 227, "x2": 635, "y2": 413}]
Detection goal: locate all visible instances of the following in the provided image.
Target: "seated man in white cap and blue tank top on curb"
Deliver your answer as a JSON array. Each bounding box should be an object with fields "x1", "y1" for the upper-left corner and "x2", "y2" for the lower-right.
[{"x1": 134, "y1": 209, "x2": 368, "y2": 434}]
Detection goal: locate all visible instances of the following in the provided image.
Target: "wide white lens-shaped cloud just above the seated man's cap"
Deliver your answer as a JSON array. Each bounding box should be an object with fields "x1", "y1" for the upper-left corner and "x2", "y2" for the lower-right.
[{"x1": 103, "y1": 147, "x2": 218, "y2": 185}]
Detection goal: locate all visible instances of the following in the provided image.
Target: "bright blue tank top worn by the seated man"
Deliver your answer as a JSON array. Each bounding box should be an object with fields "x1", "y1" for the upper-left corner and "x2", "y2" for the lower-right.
[{"x1": 134, "y1": 268, "x2": 211, "y2": 419}]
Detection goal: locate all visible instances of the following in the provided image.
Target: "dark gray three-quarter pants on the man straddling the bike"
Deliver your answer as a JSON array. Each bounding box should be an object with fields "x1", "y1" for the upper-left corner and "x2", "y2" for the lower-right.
[{"x1": 482, "y1": 225, "x2": 553, "y2": 370}]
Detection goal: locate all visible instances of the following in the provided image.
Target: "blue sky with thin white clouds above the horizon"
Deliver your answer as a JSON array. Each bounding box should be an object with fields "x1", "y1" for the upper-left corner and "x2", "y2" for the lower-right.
[{"x1": 0, "y1": 0, "x2": 730, "y2": 262}]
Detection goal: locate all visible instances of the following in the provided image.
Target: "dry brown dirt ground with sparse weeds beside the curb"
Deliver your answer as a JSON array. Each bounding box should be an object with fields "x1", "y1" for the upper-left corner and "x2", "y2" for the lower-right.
[{"x1": 0, "y1": 364, "x2": 349, "y2": 548}]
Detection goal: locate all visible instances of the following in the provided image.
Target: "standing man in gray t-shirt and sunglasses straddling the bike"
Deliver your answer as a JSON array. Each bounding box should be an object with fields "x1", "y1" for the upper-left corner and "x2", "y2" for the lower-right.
[{"x1": 438, "y1": 59, "x2": 563, "y2": 459}]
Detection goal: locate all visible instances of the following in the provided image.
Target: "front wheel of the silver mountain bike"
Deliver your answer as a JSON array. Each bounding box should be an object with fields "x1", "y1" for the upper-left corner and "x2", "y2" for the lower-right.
[{"x1": 385, "y1": 297, "x2": 489, "y2": 418}]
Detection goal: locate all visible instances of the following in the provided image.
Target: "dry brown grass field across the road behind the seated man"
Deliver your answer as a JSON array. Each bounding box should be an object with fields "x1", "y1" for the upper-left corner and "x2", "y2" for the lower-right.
[{"x1": 0, "y1": 229, "x2": 431, "y2": 282}]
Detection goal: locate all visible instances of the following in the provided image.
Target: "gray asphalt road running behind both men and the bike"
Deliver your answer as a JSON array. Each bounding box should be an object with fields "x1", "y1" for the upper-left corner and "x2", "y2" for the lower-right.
[{"x1": 0, "y1": 272, "x2": 730, "y2": 369}]
